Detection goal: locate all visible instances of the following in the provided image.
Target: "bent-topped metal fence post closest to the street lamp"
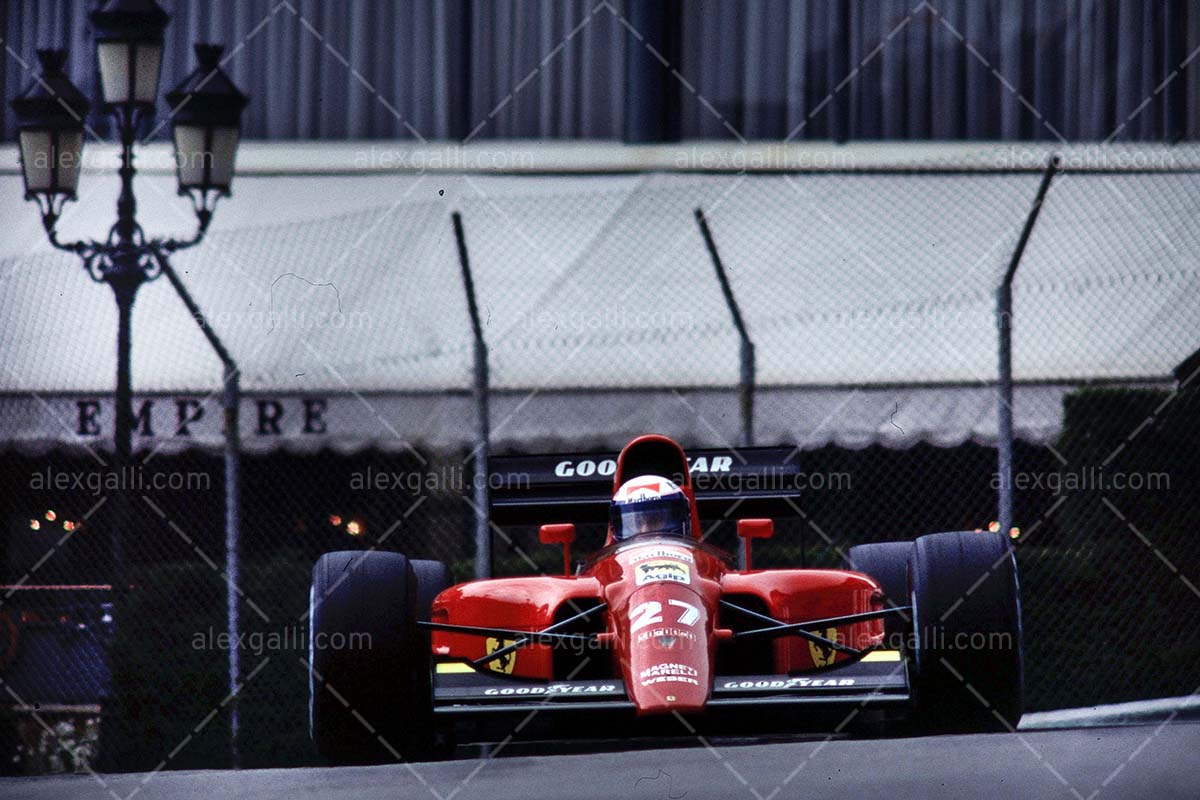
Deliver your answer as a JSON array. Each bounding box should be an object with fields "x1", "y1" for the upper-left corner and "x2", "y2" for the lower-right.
[{"x1": 156, "y1": 253, "x2": 241, "y2": 769}]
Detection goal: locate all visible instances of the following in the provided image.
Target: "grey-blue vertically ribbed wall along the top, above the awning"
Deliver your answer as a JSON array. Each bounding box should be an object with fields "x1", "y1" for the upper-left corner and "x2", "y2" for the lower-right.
[{"x1": 0, "y1": 0, "x2": 1200, "y2": 142}]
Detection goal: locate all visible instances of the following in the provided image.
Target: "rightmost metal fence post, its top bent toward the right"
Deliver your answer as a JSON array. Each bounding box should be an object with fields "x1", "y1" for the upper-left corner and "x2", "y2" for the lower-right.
[{"x1": 996, "y1": 155, "x2": 1058, "y2": 535}]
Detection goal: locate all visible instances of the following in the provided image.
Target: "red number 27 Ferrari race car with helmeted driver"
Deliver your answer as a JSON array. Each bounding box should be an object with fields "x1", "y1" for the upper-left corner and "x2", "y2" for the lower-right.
[{"x1": 310, "y1": 435, "x2": 1022, "y2": 763}]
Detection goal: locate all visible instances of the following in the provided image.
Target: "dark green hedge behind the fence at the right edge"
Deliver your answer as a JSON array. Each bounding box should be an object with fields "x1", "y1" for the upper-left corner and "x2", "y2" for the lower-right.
[{"x1": 1018, "y1": 389, "x2": 1200, "y2": 709}]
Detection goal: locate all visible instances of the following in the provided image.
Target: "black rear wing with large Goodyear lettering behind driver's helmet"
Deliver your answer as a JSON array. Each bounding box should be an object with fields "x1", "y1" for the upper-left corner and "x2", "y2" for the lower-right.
[{"x1": 488, "y1": 447, "x2": 803, "y2": 525}]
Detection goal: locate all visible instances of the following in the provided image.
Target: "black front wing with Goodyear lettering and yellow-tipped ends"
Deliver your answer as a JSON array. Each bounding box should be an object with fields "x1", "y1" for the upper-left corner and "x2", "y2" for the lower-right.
[{"x1": 433, "y1": 650, "x2": 911, "y2": 715}]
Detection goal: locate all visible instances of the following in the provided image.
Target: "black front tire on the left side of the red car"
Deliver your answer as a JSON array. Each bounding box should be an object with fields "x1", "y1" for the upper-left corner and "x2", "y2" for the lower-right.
[{"x1": 308, "y1": 551, "x2": 434, "y2": 764}]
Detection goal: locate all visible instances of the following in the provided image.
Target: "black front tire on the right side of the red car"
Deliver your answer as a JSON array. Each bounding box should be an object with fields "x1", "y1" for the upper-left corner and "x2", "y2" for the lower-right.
[{"x1": 908, "y1": 531, "x2": 1024, "y2": 733}]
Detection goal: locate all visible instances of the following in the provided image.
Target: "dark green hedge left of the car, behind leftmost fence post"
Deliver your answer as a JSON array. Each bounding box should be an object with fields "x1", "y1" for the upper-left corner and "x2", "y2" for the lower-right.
[{"x1": 101, "y1": 552, "x2": 313, "y2": 771}]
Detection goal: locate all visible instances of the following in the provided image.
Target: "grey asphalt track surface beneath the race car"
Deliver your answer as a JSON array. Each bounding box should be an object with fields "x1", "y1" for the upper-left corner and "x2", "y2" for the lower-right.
[{"x1": 0, "y1": 722, "x2": 1200, "y2": 800}]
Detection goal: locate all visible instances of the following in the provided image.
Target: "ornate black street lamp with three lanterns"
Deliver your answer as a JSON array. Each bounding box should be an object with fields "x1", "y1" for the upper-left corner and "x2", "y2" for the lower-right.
[{"x1": 12, "y1": 0, "x2": 247, "y2": 591}]
